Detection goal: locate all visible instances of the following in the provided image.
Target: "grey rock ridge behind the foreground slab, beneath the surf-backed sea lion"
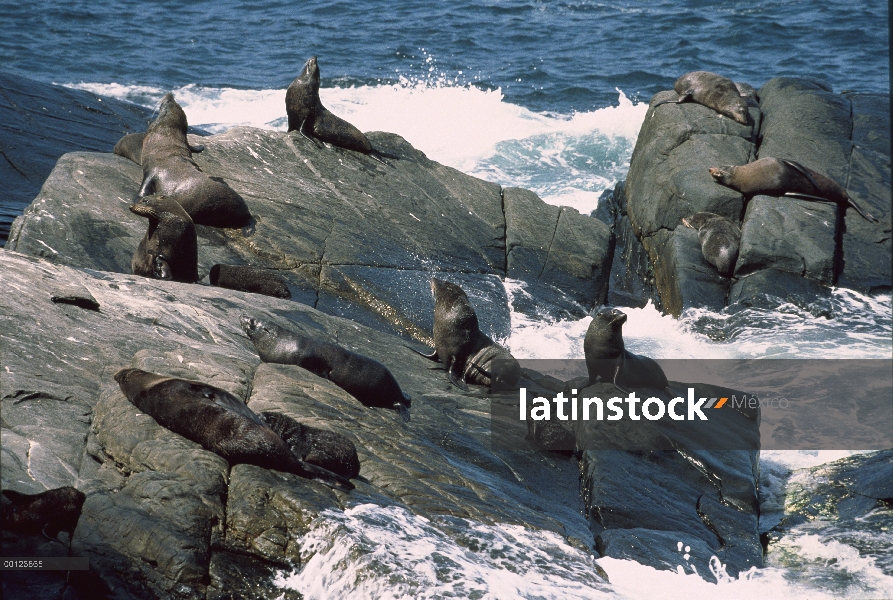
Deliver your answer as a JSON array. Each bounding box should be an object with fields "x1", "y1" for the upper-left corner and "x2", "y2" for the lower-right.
[{"x1": 8, "y1": 111, "x2": 612, "y2": 342}]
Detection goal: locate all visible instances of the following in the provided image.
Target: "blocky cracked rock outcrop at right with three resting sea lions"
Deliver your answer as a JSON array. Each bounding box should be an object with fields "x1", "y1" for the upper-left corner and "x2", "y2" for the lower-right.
[{"x1": 608, "y1": 78, "x2": 891, "y2": 316}]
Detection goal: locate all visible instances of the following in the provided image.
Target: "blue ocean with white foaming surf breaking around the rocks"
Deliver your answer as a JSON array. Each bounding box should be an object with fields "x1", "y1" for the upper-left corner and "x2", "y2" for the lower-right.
[{"x1": 0, "y1": 0, "x2": 893, "y2": 600}]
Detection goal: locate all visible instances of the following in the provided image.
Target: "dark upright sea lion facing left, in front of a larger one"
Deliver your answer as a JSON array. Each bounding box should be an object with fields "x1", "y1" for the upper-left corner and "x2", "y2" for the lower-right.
[{"x1": 130, "y1": 195, "x2": 198, "y2": 283}]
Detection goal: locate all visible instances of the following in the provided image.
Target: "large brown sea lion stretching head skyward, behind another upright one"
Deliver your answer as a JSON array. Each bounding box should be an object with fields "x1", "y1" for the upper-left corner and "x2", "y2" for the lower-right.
[{"x1": 139, "y1": 94, "x2": 251, "y2": 228}]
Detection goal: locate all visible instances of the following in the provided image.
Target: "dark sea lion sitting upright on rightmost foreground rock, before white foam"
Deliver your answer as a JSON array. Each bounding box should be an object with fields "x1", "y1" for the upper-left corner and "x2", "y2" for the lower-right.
[{"x1": 583, "y1": 307, "x2": 669, "y2": 393}]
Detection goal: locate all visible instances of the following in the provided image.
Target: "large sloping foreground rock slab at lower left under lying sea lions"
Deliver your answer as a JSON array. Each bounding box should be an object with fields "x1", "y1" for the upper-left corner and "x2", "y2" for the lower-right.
[{"x1": 0, "y1": 251, "x2": 587, "y2": 598}]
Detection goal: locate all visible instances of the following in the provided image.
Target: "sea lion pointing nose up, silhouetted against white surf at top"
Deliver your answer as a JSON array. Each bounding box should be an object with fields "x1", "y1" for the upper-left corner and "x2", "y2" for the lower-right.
[{"x1": 285, "y1": 56, "x2": 384, "y2": 163}]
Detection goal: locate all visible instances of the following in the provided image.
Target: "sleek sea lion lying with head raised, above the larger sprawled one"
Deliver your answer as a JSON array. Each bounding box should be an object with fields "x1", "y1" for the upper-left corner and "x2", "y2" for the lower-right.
[{"x1": 239, "y1": 315, "x2": 412, "y2": 421}]
